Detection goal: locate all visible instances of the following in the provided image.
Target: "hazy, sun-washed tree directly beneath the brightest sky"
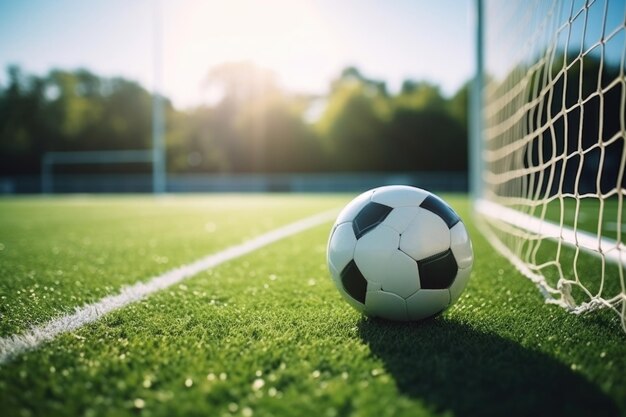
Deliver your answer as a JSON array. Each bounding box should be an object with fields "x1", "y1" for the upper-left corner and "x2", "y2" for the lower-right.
[{"x1": 204, "y1": 62, "x2": 323, "y2": 172}]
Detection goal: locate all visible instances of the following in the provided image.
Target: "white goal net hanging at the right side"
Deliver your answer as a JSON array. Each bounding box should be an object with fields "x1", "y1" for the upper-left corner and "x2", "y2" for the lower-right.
[{"x1": 473, "y1": 0, "x2": 626, "y2": 331}]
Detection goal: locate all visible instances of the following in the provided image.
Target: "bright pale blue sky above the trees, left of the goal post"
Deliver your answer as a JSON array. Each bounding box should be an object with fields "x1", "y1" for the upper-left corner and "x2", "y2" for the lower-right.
[{"x1": 0, "y1": 0, "x2": 474, "y2": 108}]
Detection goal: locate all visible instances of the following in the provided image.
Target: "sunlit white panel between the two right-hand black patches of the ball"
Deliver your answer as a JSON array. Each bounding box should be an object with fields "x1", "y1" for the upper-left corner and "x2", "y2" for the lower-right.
[{"x1": 400, "y1": 209, "x2": 450, "y2": 261}]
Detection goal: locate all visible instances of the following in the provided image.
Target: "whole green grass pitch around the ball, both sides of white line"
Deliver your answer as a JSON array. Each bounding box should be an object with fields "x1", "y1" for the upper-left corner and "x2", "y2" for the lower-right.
[{"x1": 0, "y1": 195, "x2": 626, "y2": 417}]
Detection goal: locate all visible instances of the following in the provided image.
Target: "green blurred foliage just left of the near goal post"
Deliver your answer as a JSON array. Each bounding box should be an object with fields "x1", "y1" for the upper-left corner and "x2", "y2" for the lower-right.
[{"x1": 317, "y1": 69, "x2": 467, "y2": 171}]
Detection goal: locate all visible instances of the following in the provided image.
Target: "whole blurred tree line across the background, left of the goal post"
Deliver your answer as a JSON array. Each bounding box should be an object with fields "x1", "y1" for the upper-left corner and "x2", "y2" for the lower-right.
[{"x1": 0, "y1": 62, "x2": 468, "y2": 176}]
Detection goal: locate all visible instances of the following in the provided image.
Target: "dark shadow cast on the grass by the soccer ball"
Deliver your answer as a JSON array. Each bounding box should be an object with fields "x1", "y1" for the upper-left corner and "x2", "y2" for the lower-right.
[{"x1": 359, "y1": 317, "x2": 619, "y2": 417}]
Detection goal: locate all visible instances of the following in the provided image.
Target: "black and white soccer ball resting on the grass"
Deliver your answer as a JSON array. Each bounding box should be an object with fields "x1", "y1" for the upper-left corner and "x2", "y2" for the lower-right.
[{"x1": 327, "y1": 185, "x2": 474, "y2": 321}]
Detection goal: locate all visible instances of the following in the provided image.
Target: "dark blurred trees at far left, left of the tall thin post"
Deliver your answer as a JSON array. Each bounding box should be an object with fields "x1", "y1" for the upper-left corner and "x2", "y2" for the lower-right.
[{"x1": 0, "y1": 67, "x2": 155, "y2": 174}]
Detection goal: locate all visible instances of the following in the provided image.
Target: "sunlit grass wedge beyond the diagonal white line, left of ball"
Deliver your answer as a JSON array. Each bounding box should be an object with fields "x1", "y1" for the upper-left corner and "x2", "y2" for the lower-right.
[{"x1": 0, "y1": 195, "x2": 345, "y2": 336}]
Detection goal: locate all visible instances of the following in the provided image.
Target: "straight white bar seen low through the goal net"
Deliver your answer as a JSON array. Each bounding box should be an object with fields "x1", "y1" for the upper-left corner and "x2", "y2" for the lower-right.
[{"x1": 476, "y1": 200, "x2": 626, "y2": 266}]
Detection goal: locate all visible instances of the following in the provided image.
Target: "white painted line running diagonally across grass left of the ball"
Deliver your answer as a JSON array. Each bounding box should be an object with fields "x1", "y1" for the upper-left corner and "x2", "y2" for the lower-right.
[{"x1": 0, "y1": 210, "x2": 338, "y2": 365}]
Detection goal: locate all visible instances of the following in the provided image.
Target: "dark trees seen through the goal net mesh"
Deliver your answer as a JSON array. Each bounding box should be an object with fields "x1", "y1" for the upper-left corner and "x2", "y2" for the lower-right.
[{"x1": 524, "y1": 50, "x2": 626, "y2": 195}]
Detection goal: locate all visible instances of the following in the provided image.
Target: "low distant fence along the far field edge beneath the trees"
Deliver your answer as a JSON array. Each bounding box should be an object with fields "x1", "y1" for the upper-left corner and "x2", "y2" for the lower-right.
[{"x1": 0, "y1": 172, "x2": 468, "y2": 194}]
